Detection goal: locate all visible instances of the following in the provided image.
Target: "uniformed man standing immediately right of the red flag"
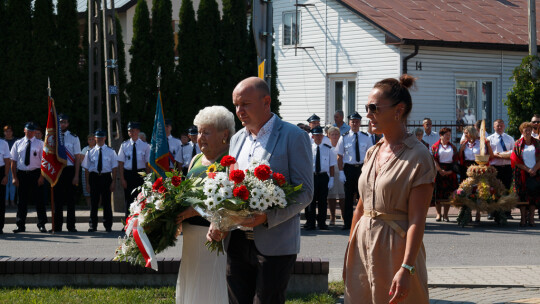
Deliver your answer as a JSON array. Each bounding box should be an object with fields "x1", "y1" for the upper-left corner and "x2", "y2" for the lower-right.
[{"x1": 54, "y1": 114, "x2": 82, "y2": 232}]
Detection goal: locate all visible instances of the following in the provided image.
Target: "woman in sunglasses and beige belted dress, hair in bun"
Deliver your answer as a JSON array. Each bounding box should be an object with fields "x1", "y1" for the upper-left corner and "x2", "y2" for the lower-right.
[{"x1": 343, "y1": 75, "x2": 436, "y2": 304}]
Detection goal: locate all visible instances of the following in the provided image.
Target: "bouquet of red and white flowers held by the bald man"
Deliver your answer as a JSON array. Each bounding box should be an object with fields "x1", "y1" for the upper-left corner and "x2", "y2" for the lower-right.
[{"x1": 190, "y1": 155, "x2": 302, "y2": 254}]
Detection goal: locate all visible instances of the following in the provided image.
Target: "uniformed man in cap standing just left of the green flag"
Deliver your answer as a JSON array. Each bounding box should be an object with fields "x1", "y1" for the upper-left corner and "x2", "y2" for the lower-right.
[{"x1": 118, "y1": 121, "x2": 150, "y2": 218}]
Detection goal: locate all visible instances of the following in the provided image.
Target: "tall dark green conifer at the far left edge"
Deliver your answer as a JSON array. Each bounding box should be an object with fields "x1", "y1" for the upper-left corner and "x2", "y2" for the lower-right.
[{"x1": 4, "y1": 0, "x2": 34, "y2": 135}]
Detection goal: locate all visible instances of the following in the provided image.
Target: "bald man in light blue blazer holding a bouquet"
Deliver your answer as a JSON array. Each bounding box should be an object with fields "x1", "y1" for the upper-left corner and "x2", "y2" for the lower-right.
[{"x1": 208, "y1": 77, "x2": 313, "y2": 304}]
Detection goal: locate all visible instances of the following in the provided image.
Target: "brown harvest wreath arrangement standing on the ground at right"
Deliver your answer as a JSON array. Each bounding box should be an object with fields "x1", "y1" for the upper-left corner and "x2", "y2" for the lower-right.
[{"x1": 451, "y1": 166, "x2": 518, "y2": 226}]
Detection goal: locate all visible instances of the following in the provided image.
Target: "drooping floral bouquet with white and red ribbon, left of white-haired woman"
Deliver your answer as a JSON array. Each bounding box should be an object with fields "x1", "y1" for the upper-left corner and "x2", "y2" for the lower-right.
[{"x1": 114, "y1": 171, "x2": 193, "y2": 270}]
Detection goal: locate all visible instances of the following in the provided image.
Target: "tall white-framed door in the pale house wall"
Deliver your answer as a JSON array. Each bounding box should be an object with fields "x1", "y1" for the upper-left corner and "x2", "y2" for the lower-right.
[{"x1": 326, "y1": 74, "x2": 356, "y2": 122}]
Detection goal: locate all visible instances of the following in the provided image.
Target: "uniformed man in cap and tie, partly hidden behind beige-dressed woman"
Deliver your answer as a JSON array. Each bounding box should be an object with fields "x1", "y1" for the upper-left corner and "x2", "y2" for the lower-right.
[{"x1": 337, "y1": 112, "x2": 373, "y2": 230}]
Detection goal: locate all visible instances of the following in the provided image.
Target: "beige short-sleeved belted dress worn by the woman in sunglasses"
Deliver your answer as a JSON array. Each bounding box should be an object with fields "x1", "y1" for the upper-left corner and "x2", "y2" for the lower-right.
[{"x1": 345, "y1": 134, "x2": 436, "y2": 304}]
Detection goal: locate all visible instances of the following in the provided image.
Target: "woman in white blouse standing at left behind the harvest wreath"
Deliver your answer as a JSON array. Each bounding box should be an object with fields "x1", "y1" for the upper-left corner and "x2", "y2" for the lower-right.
[{"x1": 459, "y1": 126, "x2": 493, "y2": 223}]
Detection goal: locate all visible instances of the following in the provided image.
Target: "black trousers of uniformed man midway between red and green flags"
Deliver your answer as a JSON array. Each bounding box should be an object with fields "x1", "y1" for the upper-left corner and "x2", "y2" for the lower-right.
[{"x1": 89, "y1": 172, "x2": 112, "y2": 229}]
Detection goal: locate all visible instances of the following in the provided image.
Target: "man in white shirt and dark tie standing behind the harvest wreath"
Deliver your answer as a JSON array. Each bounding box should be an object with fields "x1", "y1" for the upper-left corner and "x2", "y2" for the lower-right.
[{"x1": 487, "y1": 119, "x2": 515, "y2": 220}]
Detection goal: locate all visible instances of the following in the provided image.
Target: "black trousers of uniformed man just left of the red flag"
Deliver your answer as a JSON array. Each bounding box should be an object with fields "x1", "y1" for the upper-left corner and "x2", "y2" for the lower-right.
[{"x1": 16, "y1": 169, "x2": 47, "y2": 229}]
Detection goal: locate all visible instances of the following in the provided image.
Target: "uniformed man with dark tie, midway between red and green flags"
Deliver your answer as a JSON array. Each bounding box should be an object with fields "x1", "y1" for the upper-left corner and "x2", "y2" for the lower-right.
[{"x1": 82, "y1": 130, "x2": 118, "y2": 232}]
